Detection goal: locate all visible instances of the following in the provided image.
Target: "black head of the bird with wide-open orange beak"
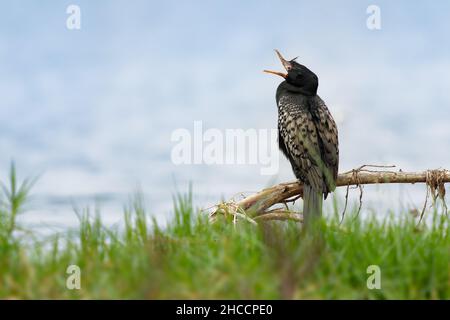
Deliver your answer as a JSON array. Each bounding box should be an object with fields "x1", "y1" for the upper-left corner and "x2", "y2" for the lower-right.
[{"x1": 264, "y1": 50, "x2": 319, "y2": 95}]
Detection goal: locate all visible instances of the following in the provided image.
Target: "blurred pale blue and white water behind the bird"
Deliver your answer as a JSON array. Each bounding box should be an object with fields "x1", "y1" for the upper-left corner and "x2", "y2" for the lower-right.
[{"x1": 0, "y1": 0, "x2": 450, "y2": 228}]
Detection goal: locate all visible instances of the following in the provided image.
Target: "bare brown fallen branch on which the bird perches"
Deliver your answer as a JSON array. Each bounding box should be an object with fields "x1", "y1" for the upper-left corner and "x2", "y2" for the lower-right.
[{"x1": 211, "y1": 165, "x2": 450, "y2": 220}]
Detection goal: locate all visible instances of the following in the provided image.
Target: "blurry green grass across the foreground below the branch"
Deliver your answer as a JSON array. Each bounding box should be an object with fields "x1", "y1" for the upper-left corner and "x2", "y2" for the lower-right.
[{"x1": 0, "y1": 167, "x2": 450, "y2": 299}]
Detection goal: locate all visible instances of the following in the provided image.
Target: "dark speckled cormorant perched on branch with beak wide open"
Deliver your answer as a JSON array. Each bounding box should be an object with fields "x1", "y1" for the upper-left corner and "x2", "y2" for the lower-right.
[{"x1": 264, "y1": 50, "x2": 339, "y2": 224}]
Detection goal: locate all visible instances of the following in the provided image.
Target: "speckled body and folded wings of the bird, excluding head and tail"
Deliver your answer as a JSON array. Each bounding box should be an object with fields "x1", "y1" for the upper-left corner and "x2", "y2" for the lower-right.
[{"x1": 278, "y1": 96, "x2": 338, "y2": 196}]
